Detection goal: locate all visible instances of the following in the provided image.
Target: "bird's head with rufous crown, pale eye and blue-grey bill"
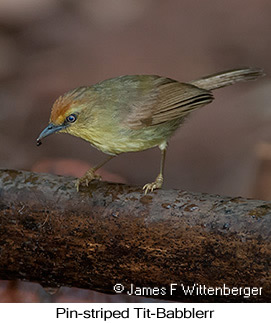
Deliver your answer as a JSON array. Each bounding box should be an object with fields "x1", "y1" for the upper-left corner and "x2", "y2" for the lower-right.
[{"x1": 37, "y1": 87, "x2": 89, "y2": 146}]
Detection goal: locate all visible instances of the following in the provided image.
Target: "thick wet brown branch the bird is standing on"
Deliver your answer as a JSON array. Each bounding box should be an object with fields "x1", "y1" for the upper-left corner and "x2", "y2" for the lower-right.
[{"x1": 0, "y1": 170, "x2": 271, "y2": 302}]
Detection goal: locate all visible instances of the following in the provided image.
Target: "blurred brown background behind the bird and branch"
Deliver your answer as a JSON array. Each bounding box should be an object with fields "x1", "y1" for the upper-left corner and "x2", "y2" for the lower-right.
[{"x1": 0, "y1": 0, "x2": 271, "y2": 301}]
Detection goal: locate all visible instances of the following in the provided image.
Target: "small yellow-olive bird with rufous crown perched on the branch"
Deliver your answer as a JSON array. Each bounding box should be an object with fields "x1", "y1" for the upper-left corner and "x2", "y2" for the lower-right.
[{"x1": 37, "y1": 68, "x2": 264, "y2": 194}]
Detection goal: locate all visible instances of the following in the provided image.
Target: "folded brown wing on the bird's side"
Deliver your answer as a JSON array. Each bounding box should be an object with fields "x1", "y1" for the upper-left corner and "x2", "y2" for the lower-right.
[{"x1": 124, "y1": 77, "x2": 213, "y2": 129}]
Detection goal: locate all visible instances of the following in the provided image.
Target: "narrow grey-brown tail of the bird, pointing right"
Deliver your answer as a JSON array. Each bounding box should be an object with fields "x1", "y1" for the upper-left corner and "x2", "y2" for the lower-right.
[{"x1": 189, "y1": 67, "x2": 265, "y2": 90}]
